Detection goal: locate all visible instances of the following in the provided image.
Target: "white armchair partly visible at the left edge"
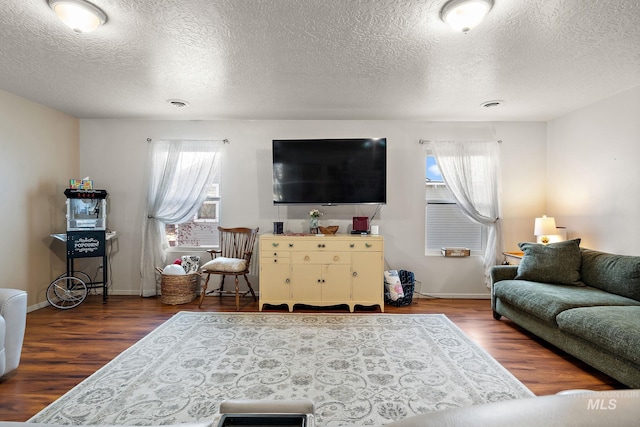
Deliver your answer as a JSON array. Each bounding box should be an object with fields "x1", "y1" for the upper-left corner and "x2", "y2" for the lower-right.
[{"x1": 0, "y1": 288, "x2": 27, "y2": 377}]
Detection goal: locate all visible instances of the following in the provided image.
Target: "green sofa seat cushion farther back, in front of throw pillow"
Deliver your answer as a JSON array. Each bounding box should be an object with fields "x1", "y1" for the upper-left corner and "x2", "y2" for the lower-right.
[{"x1": 493, "y1": 280, "x2": 640, "y2": 325}]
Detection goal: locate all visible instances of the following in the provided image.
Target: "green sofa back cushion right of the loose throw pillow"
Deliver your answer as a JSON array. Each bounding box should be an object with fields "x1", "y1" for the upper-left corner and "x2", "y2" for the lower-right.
[{"x1": 580, "y1": 249, "x2": 640, "y2": 301}]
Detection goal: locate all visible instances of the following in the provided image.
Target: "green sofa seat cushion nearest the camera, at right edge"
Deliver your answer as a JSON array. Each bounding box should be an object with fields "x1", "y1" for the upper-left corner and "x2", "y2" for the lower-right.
[{"x1": 556, "y1": 306, "x2": 640, "y2": 363}]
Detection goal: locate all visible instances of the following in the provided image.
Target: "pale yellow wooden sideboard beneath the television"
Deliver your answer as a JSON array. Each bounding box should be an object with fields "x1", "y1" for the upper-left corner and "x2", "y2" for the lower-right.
[{"x1": 260, "y1": 234, "x2": 384, "y2": 311}]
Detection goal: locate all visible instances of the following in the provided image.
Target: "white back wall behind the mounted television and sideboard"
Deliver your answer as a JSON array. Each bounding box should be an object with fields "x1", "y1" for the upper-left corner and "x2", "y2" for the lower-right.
[{"x1": 80, "y1": 120, "x2": 546, "y2": 297}]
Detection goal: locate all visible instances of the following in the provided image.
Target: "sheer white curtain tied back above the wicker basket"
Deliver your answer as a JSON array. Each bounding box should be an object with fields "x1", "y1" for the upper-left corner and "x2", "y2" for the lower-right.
[{"x1": 140, "y1": 140, "x2": 223, "y2": 297}]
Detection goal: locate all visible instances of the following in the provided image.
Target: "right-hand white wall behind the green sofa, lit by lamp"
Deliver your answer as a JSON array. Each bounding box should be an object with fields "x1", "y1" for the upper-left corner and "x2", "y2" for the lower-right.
[{"x1": 547, "y1": 87, "x2": 640, "y2": 255}]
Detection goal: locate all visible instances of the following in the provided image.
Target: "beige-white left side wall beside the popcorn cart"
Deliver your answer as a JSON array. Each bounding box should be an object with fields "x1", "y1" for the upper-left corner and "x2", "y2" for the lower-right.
[{"x1": 0, "y1": 91, "x2": 79, "y2": 309}]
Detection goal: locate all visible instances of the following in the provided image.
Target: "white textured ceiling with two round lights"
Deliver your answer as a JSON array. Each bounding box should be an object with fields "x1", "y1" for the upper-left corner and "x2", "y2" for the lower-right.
[{"x1": 0, "y1": 0, "x2": 640, "y2": 120}]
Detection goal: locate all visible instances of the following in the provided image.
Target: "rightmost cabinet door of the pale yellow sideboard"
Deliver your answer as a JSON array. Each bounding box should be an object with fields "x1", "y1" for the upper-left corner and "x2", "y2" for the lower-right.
[{"x1": 351, "y1": 252, "x2": 384, "y2": 301}]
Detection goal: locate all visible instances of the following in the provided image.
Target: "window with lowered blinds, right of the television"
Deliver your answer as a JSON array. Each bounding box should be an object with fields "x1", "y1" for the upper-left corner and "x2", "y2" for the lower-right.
[{"x1": 425, "y1": 155, "x2": 486, "y2": 255}]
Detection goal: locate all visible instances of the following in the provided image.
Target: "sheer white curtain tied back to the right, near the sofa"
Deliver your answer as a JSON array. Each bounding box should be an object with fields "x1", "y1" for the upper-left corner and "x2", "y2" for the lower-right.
[{"x1": 429, "y1": 141, "x2": 502, "y2": 283}]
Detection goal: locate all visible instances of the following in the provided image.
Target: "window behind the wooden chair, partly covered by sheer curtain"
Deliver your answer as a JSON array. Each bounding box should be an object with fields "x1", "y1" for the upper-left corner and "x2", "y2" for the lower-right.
[{"x1": 166, "y1": 161, "x2": 220, "y2": 248}]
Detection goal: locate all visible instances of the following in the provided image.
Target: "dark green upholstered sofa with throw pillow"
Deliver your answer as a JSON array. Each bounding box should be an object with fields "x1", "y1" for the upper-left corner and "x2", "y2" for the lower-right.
[{"x1": 491, "y1": 239, "x2": 640, "y2": 388}]
